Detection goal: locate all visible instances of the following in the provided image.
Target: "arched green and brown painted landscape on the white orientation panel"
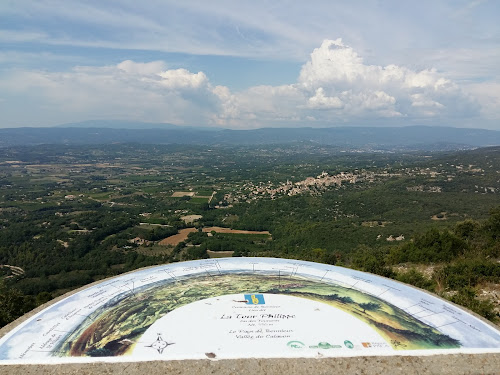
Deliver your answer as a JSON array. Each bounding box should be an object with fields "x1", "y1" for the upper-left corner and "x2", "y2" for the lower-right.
[{"x1": 53, "y1": 271, "x2": 460, "y2": 357}]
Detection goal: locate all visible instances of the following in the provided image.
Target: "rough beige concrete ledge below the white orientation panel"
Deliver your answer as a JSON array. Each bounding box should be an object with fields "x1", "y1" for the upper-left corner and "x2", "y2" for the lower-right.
[{"x1": 0, "y1": 354, "x2": 500, "y2": 375}]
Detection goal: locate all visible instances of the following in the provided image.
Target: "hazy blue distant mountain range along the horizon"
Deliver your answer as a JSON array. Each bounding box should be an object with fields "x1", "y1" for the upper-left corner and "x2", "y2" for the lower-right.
[{"x1": 0, "y1": 121, "x2": 500, "y2": 150}]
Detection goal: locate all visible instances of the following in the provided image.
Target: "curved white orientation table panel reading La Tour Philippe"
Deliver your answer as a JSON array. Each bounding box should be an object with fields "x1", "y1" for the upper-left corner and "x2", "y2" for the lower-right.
[{"x1": 0, "y1": 258, "x2": 500, "y2": 374}]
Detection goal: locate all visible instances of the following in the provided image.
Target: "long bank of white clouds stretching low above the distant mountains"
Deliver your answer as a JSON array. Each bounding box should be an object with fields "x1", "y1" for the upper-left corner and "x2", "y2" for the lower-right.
[{"x1": 0, "y1": 39, "x2": 480, "y2": 128}]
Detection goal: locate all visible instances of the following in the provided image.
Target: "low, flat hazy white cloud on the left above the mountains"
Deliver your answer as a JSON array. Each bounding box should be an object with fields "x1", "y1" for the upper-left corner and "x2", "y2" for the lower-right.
[{"x1": 0, "y1": 60, "x2": 223, "y2": 125}]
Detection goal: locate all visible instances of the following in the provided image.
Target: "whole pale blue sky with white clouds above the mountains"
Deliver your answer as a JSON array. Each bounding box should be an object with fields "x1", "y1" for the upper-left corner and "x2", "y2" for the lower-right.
[{"x1": 0, "y1": 0, "x2": 500, "y2": 130}]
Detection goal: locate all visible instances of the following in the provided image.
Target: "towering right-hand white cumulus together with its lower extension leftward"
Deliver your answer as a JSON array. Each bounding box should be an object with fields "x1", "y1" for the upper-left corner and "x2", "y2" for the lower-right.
[{"x1": 215, "y1": 39, "x2": 478, "y2": 127}]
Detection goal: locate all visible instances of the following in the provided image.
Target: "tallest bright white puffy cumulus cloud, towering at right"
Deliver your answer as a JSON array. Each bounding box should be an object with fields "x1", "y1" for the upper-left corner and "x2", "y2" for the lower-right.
[{"x1": 298, "y1": 39, "x2": 476, "y2": 120}]
